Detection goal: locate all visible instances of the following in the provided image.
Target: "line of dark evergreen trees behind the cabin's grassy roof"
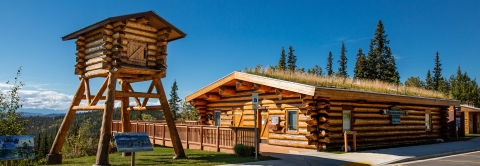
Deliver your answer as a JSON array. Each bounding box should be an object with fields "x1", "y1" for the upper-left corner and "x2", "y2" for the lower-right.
[{"x1": 270, "y1": 20, "x2": 480, "y2": 107}]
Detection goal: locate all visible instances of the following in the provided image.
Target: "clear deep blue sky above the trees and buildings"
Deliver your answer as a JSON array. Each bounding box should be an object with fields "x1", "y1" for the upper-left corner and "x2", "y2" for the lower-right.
[{"x1": 0, "y1": 0, "x2": 480, "y2": 112}]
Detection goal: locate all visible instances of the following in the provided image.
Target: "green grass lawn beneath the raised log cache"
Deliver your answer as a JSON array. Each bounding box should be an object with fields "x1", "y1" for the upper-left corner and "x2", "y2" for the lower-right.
[{"x1": 46, "y1": 147, "x2": 276, "y2": 166}]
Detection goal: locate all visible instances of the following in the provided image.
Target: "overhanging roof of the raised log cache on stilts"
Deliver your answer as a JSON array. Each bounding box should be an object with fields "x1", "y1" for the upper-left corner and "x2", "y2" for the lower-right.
[{"x1": 62, "y1": 11, "x2": 187, "y2": 41}]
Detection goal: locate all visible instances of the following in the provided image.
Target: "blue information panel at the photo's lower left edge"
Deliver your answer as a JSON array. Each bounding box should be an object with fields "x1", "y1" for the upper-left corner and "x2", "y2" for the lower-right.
[{"x1": 0, "y1": 135, "x2": 35, "y2": 160}]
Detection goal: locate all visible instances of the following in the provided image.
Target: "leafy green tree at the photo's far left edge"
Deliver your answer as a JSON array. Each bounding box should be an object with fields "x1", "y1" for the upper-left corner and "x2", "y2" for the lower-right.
[{"x1": 0, "y1": 67, "x2": 28, "y2": 136}]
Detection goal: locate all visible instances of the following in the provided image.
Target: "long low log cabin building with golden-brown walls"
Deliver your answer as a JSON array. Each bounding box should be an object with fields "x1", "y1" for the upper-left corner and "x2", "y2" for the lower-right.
[{"x1": 186, "y1": 72, "x2": 460, "y2": 150}]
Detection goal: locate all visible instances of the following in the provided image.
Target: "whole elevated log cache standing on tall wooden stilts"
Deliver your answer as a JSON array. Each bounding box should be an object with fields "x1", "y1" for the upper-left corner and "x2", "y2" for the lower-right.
[{"x1": 47, "y1": 11, "x2": 186, "y2": 165}]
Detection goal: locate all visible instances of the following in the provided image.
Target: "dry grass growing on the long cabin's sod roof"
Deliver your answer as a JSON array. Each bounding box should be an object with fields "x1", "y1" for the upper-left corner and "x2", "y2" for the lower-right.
[{"x1": 243, "y1": 66, "x2": 451, "y2": 99}]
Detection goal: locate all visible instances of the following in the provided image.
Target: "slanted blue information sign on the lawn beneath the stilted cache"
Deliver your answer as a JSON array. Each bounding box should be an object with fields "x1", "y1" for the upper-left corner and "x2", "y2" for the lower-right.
[{"x1": 113, "y1": 132, "x2": 153, "y2": 152}]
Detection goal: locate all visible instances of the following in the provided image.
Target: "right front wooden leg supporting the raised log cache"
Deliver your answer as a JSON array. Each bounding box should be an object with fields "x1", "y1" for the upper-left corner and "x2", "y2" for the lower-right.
[{"x1": 153, "y1": 79, "x2": 187, "y2": 158}]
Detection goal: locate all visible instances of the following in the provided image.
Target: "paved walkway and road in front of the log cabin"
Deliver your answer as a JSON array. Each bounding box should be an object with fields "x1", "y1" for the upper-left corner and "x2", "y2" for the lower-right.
[{"x1": 223, "y1": 137, "x2": 480, "y2": 166}]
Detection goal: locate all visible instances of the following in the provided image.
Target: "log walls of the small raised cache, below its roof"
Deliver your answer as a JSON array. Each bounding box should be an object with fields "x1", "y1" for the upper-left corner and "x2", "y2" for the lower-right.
[{"x1": 75, "y1": 19, "x2": 171, "y2": 78}]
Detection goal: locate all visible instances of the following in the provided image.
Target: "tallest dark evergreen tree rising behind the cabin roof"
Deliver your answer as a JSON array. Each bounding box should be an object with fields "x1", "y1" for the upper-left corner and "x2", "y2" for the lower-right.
[{"x1": 367, "y1": 20, "x2": 400, "y2": 83}]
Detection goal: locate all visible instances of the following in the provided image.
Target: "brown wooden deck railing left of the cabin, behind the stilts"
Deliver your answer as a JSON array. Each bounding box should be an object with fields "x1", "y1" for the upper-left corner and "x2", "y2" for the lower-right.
[{"x1": 112, "y1": 121, "x2": 260, "y2": 153}]
